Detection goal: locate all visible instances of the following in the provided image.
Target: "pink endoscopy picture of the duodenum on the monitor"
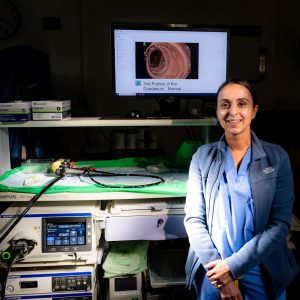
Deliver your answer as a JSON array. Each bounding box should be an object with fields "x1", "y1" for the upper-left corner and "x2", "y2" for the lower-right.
[{"x1": 135, "y1": 42, "x2": 199, "y2": 79}]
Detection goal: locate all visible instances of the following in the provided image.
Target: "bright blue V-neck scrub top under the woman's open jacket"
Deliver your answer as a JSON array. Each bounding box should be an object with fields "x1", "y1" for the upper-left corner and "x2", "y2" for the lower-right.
[{"x1": 211, "y1": 147, "x2": 254, "y2": 259}]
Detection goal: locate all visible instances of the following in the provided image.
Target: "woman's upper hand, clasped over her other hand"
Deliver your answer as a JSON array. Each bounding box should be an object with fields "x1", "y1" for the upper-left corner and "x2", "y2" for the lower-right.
[{"x1": 204, "y1": 259, "x2": 234, "y2": 289}]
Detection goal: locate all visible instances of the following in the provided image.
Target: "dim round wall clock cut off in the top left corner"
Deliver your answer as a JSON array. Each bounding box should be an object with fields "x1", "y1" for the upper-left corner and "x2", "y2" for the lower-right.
[{"x1": 0, "y1": 0, "x2": 21, "y2": 40}]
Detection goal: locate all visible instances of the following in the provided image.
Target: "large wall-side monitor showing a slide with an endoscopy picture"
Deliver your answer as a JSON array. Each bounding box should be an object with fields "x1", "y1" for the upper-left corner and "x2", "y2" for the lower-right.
[{"x1": 112, "y1": 24, "x2": 229, "y2": 99}]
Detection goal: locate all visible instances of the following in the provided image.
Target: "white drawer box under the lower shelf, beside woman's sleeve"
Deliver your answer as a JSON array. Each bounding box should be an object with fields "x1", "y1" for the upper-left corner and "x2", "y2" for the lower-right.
[{"x1": 105, "y1": 198, "x2": 187, "y2": 241}]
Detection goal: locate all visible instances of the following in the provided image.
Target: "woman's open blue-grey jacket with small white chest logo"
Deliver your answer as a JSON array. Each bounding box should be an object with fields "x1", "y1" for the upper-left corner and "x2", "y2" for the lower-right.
[{"x1": 184, "y1": 132, "x2": 299, "y2": 297}]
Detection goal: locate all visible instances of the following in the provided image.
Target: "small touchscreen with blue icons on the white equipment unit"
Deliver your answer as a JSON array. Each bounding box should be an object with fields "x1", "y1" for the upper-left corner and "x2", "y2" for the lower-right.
[{"x1": 43, "y1": 217, "x2": 91, "y2": 252}]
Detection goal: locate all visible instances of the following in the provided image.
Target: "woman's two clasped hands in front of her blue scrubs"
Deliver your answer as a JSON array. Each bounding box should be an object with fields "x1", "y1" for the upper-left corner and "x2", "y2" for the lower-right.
[{"x1": 204, "y1": 259, "x2": 243, "y2": 300}]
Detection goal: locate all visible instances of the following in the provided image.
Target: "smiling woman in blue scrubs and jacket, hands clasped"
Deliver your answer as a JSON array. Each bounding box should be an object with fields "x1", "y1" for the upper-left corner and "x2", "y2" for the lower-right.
[{"x1": 184, "y1": 80, "x2": 298, "y2": 300}]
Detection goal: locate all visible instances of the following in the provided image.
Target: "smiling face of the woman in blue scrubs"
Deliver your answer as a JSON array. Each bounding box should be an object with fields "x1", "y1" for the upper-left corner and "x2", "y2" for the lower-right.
[{"x1": 217, "y1": 83, "x2": 258, "y2": 135}]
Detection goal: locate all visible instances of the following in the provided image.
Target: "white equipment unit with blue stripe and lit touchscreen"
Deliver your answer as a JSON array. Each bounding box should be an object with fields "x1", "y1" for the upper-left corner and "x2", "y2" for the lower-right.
[{"x1": 0, "y1": 201, "x2": 101, "y2": 267}]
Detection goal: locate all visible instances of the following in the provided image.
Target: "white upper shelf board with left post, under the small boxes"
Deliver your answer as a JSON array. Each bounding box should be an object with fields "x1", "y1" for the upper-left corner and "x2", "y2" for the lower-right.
[{"x1": 0, "y1": 117, "x2": 217, "y2": 174}]
